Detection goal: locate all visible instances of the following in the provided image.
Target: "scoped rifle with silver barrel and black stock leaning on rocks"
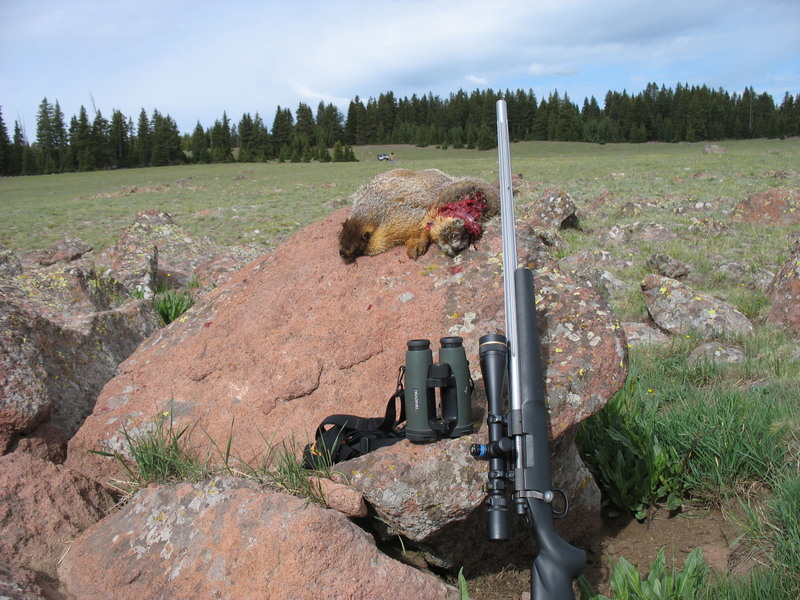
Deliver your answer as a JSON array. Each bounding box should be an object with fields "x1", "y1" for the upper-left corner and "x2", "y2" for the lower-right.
[{"x1": 472, "y1": 100, "x2": 586, "y2": 600}]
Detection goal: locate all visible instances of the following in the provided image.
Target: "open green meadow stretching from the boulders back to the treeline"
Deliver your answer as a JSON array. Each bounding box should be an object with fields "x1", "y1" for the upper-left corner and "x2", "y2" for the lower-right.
[{"x1": 0, "y1": 139, "x2": 800, "y2": 252}]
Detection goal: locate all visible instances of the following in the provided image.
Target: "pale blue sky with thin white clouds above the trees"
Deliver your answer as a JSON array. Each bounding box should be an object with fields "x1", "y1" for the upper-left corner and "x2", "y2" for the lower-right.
[{"x1": 0, "y1": 0, "x2": 800, "y2": 141}]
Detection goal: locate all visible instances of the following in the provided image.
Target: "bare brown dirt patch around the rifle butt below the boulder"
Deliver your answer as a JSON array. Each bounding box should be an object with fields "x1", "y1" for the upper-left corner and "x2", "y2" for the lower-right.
[{"x1": 469, "y1": 507, "x2": 756, "y2": 600}]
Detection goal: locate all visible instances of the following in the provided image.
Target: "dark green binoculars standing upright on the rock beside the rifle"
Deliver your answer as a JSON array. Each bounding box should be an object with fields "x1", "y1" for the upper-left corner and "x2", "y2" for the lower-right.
[{"x1": 404, "y1": 336, "x2": 475, "y2": 444}]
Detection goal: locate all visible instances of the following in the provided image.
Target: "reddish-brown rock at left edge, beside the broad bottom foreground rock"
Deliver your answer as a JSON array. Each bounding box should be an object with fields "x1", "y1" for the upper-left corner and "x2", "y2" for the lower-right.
[{"x1": 0, "y1": 452, "x2": 114, "y2": 577}]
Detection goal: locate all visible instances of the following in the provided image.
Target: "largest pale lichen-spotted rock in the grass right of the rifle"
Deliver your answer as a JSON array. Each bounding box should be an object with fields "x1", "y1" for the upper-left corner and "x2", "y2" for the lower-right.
[{"x1": 641, "y1": 274, "x2": 753, "y2": 337}]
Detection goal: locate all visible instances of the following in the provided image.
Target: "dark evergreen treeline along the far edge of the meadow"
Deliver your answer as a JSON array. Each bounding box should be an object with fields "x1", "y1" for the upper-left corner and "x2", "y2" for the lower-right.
[{"x1": 0, "y1": 83, "x2": 800, "y2": 175}]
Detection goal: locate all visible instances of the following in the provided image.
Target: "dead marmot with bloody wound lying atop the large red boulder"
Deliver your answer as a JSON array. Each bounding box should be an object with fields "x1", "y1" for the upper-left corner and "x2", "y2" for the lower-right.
[{"x1": 339, "y1": 169, "x2": 500, "y2": 264}]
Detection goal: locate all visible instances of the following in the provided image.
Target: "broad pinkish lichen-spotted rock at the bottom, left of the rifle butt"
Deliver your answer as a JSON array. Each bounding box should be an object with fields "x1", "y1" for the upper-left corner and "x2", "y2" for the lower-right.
[{"x1": 58, "y1": 478, "x2": 458, "y2": 600}]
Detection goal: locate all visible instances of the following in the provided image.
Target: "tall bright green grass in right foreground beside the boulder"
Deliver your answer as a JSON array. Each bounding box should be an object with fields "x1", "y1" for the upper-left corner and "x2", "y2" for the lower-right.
[{"x1": 578, "y1": 324, "x2": 800, "y2": 600}]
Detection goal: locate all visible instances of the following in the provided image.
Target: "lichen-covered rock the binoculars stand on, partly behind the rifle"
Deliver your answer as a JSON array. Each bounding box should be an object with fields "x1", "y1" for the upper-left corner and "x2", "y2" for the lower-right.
[{"x1": 340, "y1": 431, "x2": 600, "y2": 569}]
